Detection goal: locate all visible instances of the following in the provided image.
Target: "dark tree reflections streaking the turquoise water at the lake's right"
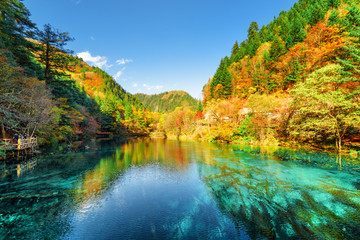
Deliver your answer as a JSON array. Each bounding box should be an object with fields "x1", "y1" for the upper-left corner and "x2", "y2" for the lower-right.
[{"x1": 199, "y1": 143, "x2": 360, "y2": 239}]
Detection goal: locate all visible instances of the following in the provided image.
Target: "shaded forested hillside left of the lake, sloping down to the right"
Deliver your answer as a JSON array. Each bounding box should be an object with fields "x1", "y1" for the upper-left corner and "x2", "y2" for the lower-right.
[{"x1": 0, "y1": 0, "x2": 150, "y2": 149}]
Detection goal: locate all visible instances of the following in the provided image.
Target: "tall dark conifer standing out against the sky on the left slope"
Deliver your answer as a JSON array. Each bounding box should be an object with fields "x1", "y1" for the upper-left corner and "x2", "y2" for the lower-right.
[{"x1": 36, "y1": 24, "x2": 74, "y2": 83}]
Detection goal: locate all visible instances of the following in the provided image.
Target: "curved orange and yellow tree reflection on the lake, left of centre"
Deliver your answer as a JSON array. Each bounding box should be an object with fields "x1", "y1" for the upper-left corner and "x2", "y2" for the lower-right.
[{"x1": 76, "y1": 139, "x2": 190, "y2": 202}]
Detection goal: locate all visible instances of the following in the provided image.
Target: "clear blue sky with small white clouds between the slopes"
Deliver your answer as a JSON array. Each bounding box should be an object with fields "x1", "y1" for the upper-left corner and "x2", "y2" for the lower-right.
[{"x1": 24, "y1": 0, "x2": 296, "y2": 98}]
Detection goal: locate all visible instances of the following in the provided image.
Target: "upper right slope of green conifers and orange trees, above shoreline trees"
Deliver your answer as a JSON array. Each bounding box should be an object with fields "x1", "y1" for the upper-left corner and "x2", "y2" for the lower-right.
[{"x1": 204, "y1": 0, "x2": 360, "y2": 102}]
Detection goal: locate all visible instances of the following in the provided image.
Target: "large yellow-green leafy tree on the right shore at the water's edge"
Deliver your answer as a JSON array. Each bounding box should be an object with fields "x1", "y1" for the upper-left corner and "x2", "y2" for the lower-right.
[{"x1": 291, "y1": 64, "x2": 360, "y2": 152}]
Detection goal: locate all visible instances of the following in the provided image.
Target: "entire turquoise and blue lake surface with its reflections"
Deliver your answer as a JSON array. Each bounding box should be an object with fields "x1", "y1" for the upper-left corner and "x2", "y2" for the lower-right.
[{"x1": 0, "y1": 140, "x2": 360, "y2": 239}]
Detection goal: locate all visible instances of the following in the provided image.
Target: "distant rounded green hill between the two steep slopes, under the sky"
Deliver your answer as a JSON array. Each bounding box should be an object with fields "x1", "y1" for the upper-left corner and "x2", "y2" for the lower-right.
[{"x1": 135, "y1": 91, "x2": 198, "y2": 112}]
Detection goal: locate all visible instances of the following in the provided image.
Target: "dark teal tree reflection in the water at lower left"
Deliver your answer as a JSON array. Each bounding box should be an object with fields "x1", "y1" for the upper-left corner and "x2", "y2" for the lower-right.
[{"x1": 0, "y1": 138, "x2": 126, "y2": 239}]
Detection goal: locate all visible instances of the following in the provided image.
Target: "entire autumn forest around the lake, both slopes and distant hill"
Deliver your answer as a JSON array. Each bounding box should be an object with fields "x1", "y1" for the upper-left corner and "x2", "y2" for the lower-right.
[{"x1": 0, "y1": 0, "x2": 360, "y2": 156}]
